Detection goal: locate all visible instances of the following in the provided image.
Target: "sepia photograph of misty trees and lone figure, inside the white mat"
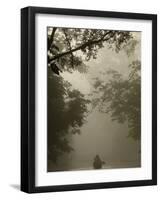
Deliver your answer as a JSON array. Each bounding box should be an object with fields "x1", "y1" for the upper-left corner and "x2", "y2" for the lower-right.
[{"x1": 46, "y1": 27, "x2": 141, "y2": 172}]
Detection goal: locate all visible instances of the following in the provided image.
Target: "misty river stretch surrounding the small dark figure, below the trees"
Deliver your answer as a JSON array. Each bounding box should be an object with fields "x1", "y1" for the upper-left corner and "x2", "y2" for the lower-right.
[{"x1": 49, "y1": 109, "x2": 140, "y2": 171}]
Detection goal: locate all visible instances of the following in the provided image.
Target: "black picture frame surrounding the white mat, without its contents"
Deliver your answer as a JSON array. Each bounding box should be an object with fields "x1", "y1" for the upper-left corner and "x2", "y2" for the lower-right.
[{"x1": 21, "y1": 7, "x2": 157, "y2": 193}]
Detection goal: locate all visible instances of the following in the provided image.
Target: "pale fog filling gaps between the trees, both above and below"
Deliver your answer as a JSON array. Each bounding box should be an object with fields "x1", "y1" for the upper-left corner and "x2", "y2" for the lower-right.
[{"x1": 48, "y1": 33, "x2": 141, "y2": 170}]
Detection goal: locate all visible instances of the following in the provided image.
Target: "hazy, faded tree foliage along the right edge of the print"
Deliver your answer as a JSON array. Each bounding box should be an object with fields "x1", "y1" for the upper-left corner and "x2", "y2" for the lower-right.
[{"x1": 93, "y1": 61, "x2": 141, "y2": 139}]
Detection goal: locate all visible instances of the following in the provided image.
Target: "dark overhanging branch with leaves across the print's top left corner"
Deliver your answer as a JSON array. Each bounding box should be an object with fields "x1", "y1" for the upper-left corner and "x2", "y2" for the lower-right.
[{"x1": 48, "y1": 27, "x2": 132, "y2": 72}]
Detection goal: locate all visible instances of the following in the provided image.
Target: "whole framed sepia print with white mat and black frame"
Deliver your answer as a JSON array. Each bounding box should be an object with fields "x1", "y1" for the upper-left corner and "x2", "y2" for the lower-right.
[{"x1": 21, "y1": 7, "x2": 157, "y2": 193}]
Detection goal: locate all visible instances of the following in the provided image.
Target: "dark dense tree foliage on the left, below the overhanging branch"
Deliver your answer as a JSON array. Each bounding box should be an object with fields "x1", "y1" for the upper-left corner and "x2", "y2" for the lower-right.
[{"x1": 48, "y1": 68, "x2": 89, "y2": 162}]
